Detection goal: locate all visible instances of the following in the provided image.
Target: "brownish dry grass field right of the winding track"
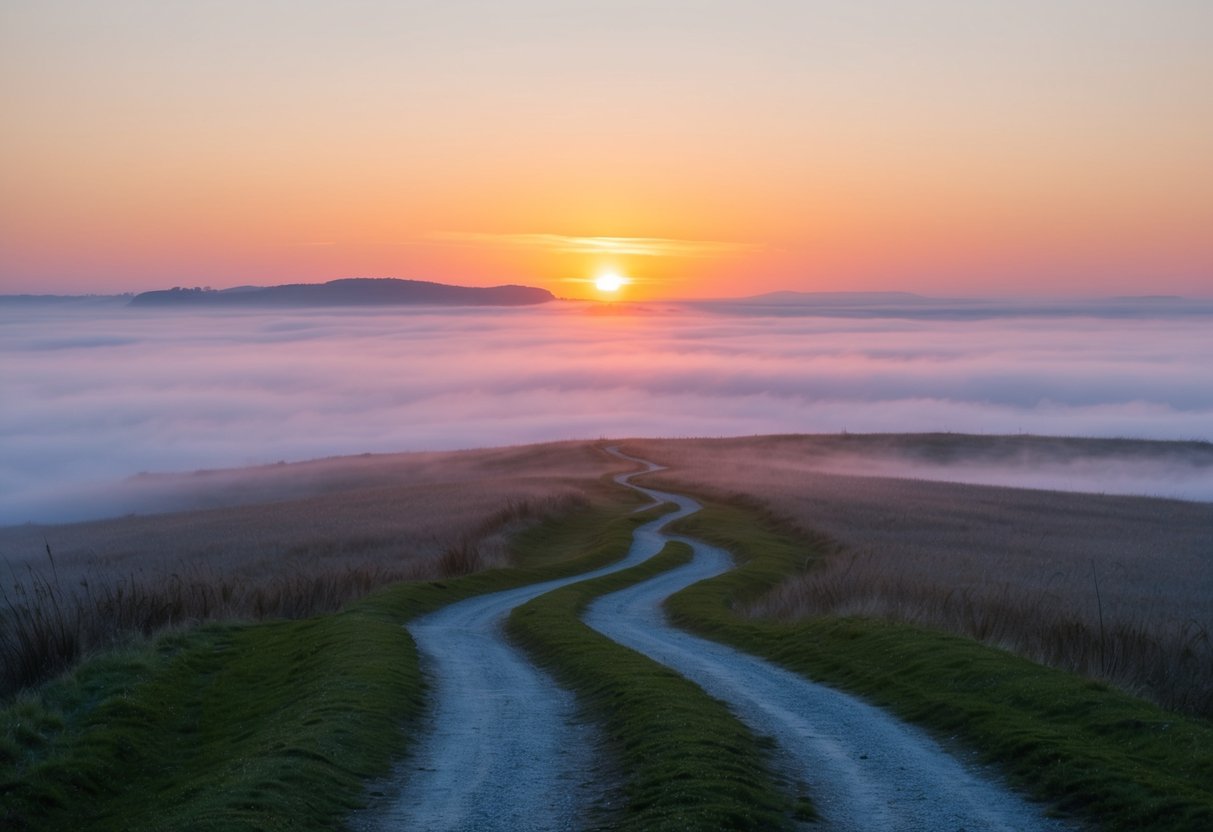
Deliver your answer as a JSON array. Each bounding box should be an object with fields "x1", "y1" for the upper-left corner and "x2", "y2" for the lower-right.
[{"x1": 626, "y1": 435, "x2": 1213, "y2": 716}]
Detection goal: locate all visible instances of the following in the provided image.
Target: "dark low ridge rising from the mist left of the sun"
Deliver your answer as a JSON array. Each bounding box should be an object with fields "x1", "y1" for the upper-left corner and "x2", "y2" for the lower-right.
[{"x1": 131, "y1": 278, "x2": 556, "y2": 307}]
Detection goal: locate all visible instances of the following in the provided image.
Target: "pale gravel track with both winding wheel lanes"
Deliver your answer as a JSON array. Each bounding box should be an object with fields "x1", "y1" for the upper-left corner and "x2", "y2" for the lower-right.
[{"x1": 349, "y1": 449, "x2": 1069, "y2": 832}]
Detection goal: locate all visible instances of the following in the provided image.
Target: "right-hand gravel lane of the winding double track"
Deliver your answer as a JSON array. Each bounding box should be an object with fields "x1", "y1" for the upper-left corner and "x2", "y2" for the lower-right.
[{"x1": 583, "y1": 449, "x2": 1070, "y2": 832}]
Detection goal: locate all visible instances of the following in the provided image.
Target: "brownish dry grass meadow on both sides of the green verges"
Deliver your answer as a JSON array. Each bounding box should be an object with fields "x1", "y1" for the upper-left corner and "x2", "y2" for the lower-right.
[{"x1": 0, "y1": 434, "x2": 1213, "y2": 716}]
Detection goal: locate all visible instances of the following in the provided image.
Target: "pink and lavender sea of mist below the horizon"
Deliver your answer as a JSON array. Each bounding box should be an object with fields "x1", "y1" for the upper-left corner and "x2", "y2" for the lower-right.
[{"x1": 0, "y1": 302, "x2": 1213, "y2": 523}]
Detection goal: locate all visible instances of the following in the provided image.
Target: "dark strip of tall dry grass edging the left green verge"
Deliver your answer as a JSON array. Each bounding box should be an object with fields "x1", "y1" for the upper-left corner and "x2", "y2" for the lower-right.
[{"x1": 0, "y1": 492, "x2": 587, "y2": 695}]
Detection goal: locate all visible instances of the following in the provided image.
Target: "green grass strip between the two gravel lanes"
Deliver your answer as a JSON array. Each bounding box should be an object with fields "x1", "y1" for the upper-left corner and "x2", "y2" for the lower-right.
[{"x1": 508, "y1": 543, "x2": 809, "y2": 832}]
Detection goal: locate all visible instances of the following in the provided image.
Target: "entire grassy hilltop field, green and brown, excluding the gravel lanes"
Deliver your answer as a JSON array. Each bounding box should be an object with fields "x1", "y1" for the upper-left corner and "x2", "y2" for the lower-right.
[{"x1": 0, "y1": 435, "x2": 1213, "y2": 832}]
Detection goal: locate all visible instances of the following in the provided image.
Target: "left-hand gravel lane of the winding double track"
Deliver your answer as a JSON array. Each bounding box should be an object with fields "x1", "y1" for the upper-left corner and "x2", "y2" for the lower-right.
[{"x1": 349, "y1": 463, "x2": 694, "y2": 832}]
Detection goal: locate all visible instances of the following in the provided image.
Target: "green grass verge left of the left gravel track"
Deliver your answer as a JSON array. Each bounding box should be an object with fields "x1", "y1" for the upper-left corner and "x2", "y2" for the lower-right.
[{"x1": 0, "y1": 494, "x2": 644, "y2": 832}]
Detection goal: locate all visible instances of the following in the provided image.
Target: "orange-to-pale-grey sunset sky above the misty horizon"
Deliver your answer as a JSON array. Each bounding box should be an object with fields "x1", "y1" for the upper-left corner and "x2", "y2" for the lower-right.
[{"x1": 0, "y1": 0, "x2": 1213, "y2": 300}]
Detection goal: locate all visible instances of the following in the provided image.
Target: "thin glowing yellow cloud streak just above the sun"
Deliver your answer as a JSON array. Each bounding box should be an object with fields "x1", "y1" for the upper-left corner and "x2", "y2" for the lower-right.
[{"x1": 427, "y1": 232, "x2": 763, "y2": 257}]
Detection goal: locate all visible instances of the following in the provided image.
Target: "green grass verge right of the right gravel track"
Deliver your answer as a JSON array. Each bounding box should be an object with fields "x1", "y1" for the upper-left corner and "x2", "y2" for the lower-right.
[{"x1": 667, "y1": 503, "x2": 1213, "y2": 832}]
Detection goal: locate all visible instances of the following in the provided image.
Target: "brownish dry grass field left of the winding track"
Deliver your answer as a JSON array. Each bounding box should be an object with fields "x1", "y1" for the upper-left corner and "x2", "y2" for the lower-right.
[{"x1": 0, "y1": 443, "x2": 626, "y2": 693}]
